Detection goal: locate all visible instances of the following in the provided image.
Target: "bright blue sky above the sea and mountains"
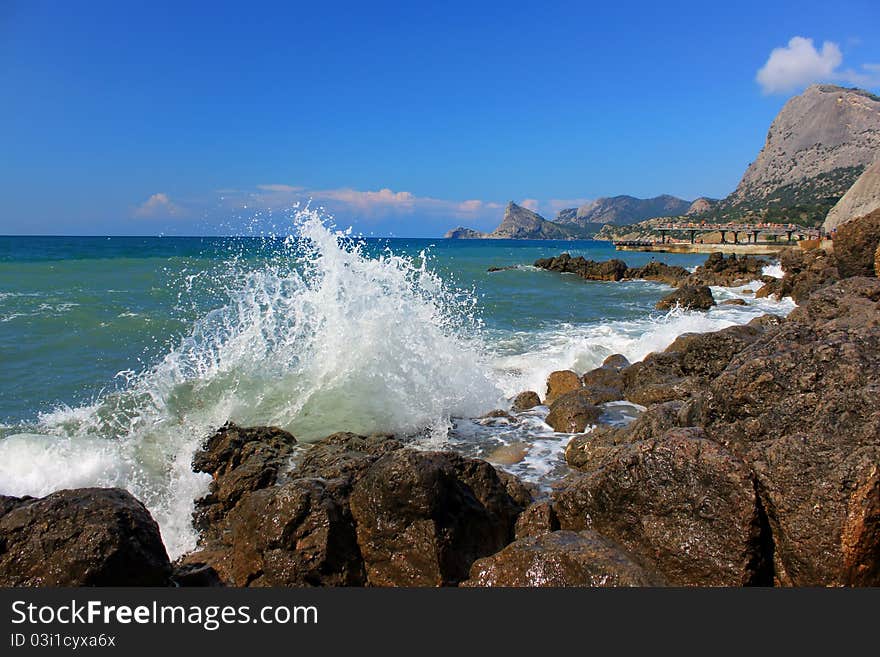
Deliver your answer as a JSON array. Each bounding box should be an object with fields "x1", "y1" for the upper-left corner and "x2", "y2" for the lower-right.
[{"x1": 0, "y1": 0, "x2": 880, "y2": 236}]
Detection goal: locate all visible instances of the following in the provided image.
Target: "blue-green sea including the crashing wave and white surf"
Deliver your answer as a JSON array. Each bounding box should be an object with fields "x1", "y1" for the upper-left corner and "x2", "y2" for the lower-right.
[{"x1": 0, "y1": 208, "x2": 794, "y2": 558}]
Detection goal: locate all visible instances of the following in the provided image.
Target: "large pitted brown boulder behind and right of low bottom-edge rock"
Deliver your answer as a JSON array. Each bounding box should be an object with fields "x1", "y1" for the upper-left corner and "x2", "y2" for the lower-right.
[{"x1": 554, "y1": 428, "x2": 769, "y2": 586}]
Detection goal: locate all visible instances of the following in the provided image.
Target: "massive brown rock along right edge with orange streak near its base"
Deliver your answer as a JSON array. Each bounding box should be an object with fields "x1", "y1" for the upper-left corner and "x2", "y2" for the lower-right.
[{"x1": 700, "y1": 278, "x2": 880, "y2": 586}]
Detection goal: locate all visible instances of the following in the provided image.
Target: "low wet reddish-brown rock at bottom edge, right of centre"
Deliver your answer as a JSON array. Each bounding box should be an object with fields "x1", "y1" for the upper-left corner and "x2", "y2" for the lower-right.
[{"x1": 463, "y1": 531, "x2": 663, "y2": 586}]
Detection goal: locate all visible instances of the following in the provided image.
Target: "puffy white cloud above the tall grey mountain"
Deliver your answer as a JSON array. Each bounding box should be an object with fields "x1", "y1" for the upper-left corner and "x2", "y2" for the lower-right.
[{"x1": 755, "y1": 36, "x2": 880, "y2": 94}]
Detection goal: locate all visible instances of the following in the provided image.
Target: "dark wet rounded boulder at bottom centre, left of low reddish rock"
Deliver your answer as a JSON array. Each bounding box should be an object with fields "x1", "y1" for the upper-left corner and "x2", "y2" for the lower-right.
[{"x1": 351, "y1": 450, "x2": 522, "y2": 586}]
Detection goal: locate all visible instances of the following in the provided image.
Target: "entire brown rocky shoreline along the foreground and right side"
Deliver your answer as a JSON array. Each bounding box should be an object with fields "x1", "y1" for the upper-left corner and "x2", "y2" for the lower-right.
[{"x1": 0, "y1": 215, "x2": 880, "y2": 587}]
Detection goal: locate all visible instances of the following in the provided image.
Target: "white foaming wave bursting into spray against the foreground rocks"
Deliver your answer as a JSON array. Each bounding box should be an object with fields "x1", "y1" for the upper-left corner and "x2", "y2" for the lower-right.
[{"x1": 0, "y1": 208, "x2": 502, "y2": 557}]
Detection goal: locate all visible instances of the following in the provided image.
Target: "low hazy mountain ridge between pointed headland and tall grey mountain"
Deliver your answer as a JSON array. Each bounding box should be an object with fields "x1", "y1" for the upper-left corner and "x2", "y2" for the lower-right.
[{"x1": 557, "y1": 194, "x2": 692, "y2": 227}]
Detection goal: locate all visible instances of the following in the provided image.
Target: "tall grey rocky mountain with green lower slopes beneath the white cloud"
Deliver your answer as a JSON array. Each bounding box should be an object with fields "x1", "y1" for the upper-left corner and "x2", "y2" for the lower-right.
[{"x1": 709, "y1": 85, "x2": 880, "y2": 225}]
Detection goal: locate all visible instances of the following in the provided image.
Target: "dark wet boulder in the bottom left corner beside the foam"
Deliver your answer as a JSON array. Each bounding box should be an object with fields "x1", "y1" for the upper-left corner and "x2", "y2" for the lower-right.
[{"x1": 0, "y1": 488, "x2": 171, "y2": 586}]
